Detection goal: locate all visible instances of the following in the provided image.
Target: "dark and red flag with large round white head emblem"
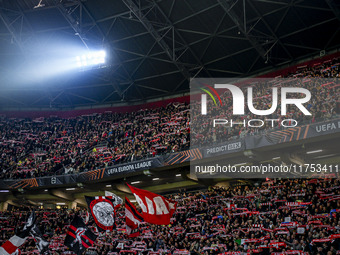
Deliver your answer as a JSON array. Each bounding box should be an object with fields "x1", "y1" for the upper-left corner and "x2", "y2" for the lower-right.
[{"x1": 85, "y1": 196, "x2": 120, "y2": 232}]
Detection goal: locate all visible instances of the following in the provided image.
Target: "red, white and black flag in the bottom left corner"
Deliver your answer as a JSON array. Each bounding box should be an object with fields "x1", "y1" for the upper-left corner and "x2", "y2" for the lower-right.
[{"x1": 0, "y1": 211, "x2": 36, "y2": 255}]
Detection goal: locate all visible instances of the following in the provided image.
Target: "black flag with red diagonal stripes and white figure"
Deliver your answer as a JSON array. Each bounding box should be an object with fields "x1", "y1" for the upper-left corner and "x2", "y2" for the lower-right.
[{"x1": 64, "y1": 215, "x2": 97, "y2": 255}]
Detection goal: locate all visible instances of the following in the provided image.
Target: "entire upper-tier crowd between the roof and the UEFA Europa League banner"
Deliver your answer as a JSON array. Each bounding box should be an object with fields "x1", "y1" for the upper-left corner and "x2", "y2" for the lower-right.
[{"x1": 0, "y1": 56, "x2": 340, "y2": 179}]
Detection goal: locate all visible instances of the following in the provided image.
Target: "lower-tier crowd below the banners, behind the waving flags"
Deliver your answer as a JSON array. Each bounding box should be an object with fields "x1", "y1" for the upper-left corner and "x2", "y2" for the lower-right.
[{"x1": 0, "y1": 176, "x2": 340, "y2": 255}]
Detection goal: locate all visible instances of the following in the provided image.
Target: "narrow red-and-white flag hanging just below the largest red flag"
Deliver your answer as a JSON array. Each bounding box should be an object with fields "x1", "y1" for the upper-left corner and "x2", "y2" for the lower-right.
[{"x1": 125, "y1": 197, "x2": 143, "y2": 237}]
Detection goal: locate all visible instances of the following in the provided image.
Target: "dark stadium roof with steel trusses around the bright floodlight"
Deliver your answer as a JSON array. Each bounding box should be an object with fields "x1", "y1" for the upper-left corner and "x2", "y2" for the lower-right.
[{"x1": 0, "y1": 0, "x2": 340, "y2": 109}]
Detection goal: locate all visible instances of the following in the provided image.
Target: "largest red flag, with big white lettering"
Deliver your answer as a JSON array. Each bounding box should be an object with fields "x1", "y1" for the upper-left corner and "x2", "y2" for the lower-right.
[{"x1": 127, "y1": 184, "x2": 177, "y2": 225}]
